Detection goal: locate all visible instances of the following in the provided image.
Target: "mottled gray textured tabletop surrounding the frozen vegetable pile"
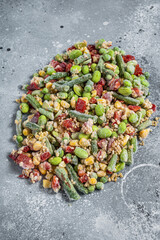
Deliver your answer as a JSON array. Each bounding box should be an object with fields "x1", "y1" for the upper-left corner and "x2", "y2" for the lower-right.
[{"x1": 0, "y1": 0, "x2": 160, "y2": 240}]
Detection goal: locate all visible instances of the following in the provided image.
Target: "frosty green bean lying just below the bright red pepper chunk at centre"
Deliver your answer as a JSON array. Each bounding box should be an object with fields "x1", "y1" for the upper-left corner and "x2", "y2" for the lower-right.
[{"x1": 68, "y1": 110, "x2": 98, "y2": 123}]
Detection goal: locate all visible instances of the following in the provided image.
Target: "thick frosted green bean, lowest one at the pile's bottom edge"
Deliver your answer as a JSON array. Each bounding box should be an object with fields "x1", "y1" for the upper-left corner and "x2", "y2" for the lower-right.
[{"x1": 55, "y1": 167, "x2": 80, "y2": 200}]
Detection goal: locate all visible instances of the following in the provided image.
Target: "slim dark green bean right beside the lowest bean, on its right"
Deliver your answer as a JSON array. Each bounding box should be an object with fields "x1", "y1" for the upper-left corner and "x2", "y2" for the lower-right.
[{"x1": 66, "y1": 163, "x2": 88, "y2": 194}]
